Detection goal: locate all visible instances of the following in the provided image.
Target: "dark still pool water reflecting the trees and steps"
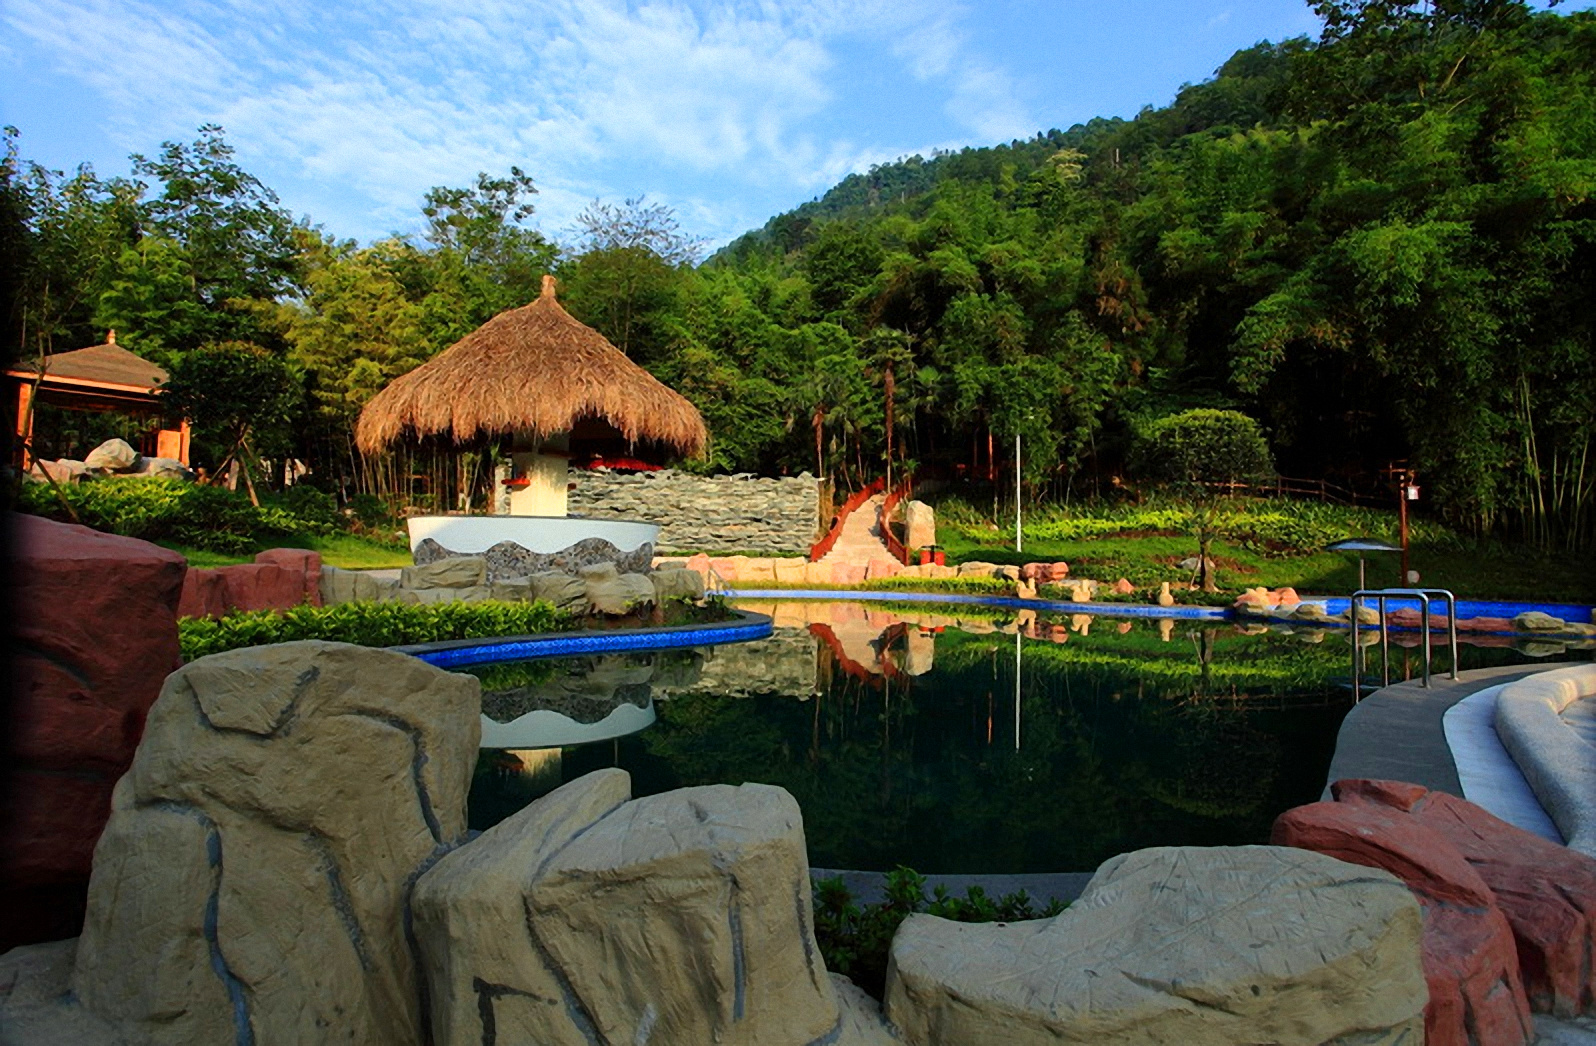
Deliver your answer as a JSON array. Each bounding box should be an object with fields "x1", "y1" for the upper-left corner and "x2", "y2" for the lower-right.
[{"x1": 471, "y1": 602, "x2": 1583, "y2": 874}]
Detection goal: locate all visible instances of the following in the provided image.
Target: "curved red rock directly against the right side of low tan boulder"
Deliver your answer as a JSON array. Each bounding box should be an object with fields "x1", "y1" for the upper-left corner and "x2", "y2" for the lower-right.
[{"x1": 1270, "y1": 802, "x2": 1534, "y2": 1046}]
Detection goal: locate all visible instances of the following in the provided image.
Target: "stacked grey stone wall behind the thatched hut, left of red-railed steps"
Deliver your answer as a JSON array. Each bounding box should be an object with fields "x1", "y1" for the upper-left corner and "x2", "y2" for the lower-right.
[{"x1": 570, "y1": 470, "x2": 820, "y2": 553}]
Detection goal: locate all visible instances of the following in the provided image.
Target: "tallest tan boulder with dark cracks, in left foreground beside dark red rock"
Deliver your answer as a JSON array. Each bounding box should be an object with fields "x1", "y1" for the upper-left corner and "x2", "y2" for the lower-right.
[{"x1": 73, "y1": 642, "x2": 480, "y2": 1044}]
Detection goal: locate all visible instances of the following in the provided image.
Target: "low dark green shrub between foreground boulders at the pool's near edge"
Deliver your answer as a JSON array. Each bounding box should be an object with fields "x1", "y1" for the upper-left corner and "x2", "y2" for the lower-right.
[{"x1": 814, "y1": 867, "x2": 1068, "y2": 998}]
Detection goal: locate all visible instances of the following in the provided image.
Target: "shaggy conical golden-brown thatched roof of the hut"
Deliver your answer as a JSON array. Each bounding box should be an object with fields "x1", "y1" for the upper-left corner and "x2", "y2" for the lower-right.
[{"x1": 365, "y1": 276, "x2": 709, "y2": 454}]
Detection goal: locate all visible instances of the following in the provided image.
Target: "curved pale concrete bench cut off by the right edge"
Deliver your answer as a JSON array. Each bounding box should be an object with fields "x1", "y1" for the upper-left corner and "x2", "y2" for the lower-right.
[{"x1": 1495, "y1": 664, "x2": 1596, "y2": 856}]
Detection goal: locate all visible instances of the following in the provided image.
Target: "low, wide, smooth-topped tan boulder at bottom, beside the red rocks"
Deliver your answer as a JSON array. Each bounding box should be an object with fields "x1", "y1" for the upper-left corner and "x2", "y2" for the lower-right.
[{"x1": 886, "y1": 846, "x2": 1427, "y2": 1046}]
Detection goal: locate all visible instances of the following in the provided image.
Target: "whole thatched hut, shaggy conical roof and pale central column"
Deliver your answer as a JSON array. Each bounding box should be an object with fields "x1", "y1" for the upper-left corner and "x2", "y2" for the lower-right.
[{"x1": 365, "y1": 269, "x2": 709, "y2": 516}]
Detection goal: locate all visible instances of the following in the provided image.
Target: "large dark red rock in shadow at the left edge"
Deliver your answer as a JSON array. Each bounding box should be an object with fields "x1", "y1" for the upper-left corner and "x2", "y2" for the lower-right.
[{"x1": 0, "y1": 516, "x2": 187, "y2": 952}]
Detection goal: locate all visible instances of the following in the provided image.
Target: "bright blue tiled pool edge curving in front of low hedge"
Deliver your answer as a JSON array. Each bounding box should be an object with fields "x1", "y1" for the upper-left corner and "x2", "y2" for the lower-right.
[{"x1": 389, "y1": 610, "x2": 774, "y2": 668}]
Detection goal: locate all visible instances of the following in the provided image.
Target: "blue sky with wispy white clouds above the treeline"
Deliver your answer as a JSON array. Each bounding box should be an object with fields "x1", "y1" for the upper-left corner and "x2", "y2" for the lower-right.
[{"x1": 0, "y1": 0, "x2": 1557, "y2": 244}]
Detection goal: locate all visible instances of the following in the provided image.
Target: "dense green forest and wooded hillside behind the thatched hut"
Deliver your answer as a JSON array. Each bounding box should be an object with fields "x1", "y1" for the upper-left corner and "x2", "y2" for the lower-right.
[{"x1": 0, "y1": 0, "x2": 1596, "y2": 546}]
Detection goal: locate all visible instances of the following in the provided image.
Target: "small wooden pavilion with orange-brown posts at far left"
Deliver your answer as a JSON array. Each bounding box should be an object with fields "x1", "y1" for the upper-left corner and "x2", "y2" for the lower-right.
[{"x1": 5, "y1": 331, "x2": 190, "y2": 471}]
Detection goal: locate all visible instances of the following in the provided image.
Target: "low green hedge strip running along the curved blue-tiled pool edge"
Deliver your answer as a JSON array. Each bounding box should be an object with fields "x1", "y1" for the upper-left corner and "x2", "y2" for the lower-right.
[{"x1": 177, "y1": 600, "x2": 571, "y2": 661}]
